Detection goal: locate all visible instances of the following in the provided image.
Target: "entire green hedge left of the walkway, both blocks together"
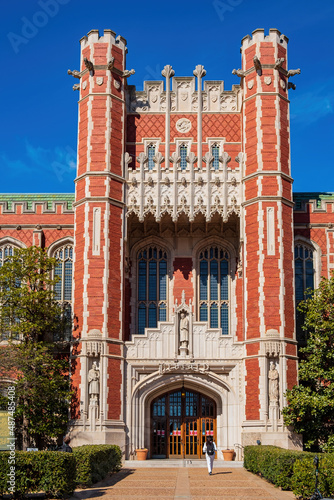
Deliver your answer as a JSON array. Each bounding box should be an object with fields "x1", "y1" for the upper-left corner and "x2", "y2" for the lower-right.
[{"x1": 0, "y1": 445, "x2": 122, "y2": 498}]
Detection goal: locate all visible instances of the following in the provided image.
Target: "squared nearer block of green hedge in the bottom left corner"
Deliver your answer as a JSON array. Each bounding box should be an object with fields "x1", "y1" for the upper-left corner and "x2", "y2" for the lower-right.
[{"x1": 0, "y1": 451, "x2": 76, "y2": 498}]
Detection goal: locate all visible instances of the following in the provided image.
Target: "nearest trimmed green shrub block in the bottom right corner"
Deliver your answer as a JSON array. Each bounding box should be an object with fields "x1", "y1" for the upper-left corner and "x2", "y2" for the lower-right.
[{"x1": 291, "y1": 453, "x2": 334, "y2": 499}]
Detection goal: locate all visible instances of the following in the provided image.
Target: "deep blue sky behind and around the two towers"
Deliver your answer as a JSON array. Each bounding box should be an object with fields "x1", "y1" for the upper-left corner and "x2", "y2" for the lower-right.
[{"x1": 0, "y1": 0, "x2": 334, "y2": 193}]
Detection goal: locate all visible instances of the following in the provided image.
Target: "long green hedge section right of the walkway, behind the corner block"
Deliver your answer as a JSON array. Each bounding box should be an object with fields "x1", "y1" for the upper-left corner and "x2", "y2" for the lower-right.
[{"x1": 244, "y1": 445, "x2": 314, "y2": 490}]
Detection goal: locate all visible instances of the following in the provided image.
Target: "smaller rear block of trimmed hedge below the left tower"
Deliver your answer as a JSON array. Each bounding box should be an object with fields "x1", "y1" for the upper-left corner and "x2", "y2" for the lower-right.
[{"x1": 73, "y1": 444, "x2": 122, "y2": 486}]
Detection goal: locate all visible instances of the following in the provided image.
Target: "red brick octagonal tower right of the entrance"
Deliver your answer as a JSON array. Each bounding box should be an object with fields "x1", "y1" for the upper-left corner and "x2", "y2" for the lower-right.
[{"x1": 240, "y1": 29, "x2": 297, "y2": 442}]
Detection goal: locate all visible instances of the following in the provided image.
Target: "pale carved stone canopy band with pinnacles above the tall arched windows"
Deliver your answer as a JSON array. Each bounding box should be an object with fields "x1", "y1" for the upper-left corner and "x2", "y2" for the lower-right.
[{"x1": 126, "y1": 152, "x2": 241, "y2": 222}]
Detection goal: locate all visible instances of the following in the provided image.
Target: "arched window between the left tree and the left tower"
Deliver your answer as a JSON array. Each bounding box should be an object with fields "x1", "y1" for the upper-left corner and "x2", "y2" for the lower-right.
[{"x1": 53, "y1": 243, "x2": 73, "y2": 340}]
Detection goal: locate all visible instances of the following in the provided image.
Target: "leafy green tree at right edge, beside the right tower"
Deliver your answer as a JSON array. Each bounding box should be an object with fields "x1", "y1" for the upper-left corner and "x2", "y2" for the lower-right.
[{"x1": 283, "y1": 273, "x2": 334, "y2": 451}]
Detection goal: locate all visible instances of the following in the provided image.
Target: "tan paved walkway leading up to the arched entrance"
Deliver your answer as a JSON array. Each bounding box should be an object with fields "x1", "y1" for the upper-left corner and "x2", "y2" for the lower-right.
[{"x1": 71, "y1": 467, "x2": 295, "y2": 500}]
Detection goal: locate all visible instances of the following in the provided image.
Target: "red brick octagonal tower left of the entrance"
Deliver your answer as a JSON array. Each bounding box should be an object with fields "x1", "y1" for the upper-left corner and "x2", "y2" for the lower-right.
[{"x1": 73, "y1": 30, "x2": 128, "y2": 444}]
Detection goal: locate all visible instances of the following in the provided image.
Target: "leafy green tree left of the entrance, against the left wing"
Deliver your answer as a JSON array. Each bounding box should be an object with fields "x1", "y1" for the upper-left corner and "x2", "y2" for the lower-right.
[{"x1": 0, "y1": 247, "x2": 72, "y2": 448}]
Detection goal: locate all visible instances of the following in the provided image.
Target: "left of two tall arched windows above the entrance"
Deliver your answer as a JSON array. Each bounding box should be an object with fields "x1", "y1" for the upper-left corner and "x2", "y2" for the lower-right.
[{"x1": 137, "y1": 245, "x2": 167, "y2": 334}]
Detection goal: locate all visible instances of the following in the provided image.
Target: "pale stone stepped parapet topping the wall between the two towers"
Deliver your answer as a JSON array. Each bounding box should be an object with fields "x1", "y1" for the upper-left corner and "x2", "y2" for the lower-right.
[{"x1": 127, "y1": 76, "x2": 242, "y2": 113}]
